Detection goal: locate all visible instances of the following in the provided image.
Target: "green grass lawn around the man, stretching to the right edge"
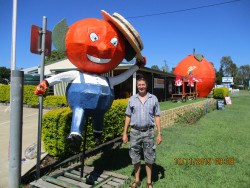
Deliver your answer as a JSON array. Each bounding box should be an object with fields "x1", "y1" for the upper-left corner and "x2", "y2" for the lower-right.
[{"x1": 87, "y1": 92, "x2": 250, "y2": 188}]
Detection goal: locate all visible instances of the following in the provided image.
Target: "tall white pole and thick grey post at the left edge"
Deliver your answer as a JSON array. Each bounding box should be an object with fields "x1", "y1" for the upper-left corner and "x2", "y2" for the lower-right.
[{"x1": 8, "y1": 0, "x2": 24, "y2": 188}]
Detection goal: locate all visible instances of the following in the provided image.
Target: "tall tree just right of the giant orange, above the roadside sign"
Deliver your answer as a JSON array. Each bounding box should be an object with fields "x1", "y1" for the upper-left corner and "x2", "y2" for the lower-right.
[{"x1": 220, "y1": 56, "x2": 238, "y2": 77}]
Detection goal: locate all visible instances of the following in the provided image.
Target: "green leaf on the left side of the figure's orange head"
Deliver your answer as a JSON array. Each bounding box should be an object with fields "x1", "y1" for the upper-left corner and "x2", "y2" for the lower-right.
[{"x1": 52, "y1": 19, "x2": 68, "y2": 52}]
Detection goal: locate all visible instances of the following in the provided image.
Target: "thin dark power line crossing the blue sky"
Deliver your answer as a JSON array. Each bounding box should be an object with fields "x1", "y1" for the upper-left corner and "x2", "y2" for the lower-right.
[{"x1": 126, "y1": 0, "x2": 240, "y2": 19}]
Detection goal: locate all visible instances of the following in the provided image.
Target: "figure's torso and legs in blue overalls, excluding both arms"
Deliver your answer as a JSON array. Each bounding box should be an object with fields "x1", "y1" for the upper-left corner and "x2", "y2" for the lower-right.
[{"x1": 66, "y1": 72, "x2": 114, "y2": 135}]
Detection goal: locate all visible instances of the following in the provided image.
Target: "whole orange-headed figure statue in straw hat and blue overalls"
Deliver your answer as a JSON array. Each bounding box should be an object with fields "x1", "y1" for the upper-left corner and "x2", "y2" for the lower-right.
[{"x1": 35, "y1": 10, "x2": 146, "y2": 151}]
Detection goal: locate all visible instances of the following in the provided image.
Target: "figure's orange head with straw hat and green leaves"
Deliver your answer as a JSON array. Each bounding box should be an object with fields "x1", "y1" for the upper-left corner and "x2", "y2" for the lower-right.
[{"x1": 52, "y1": 10, "x2": 146, "y2": 74}]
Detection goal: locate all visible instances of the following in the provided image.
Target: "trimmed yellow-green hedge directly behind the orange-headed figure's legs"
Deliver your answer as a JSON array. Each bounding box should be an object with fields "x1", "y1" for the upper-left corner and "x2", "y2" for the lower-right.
[{"x1": 42, "y1": 99, "x2": 128, "y2": 158}]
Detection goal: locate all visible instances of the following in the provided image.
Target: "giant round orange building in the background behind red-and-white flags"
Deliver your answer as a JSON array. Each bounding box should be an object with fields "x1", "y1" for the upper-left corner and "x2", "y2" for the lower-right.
[{"x1": 174, "y1": 54, "x2": 216, "y2": 97}]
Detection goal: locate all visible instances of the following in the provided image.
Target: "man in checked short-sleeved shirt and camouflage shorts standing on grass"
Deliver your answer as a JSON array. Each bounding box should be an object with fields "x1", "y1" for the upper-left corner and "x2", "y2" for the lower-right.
[{"x1": 122, "y1": 77, "x2": 162, "y2": 188}]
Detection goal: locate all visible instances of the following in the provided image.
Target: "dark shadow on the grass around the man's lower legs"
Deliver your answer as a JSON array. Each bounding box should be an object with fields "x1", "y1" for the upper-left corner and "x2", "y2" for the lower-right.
[{"x1": 93, "y1": 148, "x2": 165, "y2": 182}]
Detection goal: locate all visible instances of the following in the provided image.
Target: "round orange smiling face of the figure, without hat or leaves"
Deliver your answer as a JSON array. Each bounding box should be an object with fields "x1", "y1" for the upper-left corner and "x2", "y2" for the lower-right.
[{"x1": 65, "y1": 18, "x2": 125, "y2": 74}]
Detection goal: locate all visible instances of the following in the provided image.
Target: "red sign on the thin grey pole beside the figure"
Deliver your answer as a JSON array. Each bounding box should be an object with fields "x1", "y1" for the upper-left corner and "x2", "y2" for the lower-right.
[{"x1": 30, "y1": 25, "x2": 52, "y2": 56}]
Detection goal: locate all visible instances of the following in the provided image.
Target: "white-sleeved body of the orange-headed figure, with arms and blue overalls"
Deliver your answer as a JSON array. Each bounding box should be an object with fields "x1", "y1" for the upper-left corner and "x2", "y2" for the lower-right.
[{"x1": 46, "y1": 65, "x2": 139, "y2": 145}]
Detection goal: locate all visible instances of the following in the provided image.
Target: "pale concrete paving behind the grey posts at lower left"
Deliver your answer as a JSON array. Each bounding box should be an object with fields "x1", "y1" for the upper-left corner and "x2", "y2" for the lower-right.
[{"x1": 0, "y1": 104, "x2": 48, "y2": 188}]
